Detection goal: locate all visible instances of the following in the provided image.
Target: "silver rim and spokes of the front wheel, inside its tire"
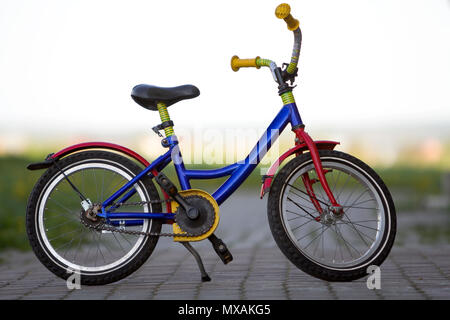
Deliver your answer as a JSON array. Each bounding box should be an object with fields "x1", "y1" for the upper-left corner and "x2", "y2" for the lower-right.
[{"x1": 280, "y1": 157, "x2": 390, "y2": 270}]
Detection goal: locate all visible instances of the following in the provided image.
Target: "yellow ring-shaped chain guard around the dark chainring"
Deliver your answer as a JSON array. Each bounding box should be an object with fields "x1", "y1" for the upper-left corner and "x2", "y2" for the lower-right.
[{"x1": 171, "y1": 189, "x2": 220, "y2": 242}]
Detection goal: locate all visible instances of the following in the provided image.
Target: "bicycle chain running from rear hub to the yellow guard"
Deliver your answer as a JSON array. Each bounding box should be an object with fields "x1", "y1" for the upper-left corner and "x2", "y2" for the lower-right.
[{"x1": 81, "y1": 200, "x2": 196, "y2": 237}]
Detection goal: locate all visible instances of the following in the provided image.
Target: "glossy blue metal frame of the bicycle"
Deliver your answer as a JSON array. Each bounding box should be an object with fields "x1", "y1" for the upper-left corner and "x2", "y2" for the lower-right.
[{"x1": 98, "y1": 103, "x2": 303, "y2": 225}]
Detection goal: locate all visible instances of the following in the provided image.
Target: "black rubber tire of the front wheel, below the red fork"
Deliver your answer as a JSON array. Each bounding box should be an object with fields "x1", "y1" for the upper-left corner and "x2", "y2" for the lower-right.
[{"x1": 268, "y1": 150, "x2": 396, "y2": 281}]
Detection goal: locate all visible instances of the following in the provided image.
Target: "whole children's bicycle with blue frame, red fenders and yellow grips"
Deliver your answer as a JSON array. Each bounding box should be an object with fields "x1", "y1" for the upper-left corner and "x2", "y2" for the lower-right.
[{"x1": 26, "y1": 4, "x2": 396, "y2": 285}]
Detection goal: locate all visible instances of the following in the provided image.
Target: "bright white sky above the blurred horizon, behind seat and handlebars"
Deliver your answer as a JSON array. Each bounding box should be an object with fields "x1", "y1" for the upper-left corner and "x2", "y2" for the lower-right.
[{"x1": 0, "y1": 0, "x2": 450, "y2": 135}]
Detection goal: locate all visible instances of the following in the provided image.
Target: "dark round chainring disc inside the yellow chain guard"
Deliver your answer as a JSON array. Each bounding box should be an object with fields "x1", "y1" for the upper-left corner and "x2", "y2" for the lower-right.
[{"x1": 175, "y1": 195, "x2": 216, "y2": 236}]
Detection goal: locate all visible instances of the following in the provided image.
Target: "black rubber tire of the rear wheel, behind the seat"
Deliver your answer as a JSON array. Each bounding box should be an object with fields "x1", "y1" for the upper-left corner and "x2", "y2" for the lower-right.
[{"x1": 26, "y1": 151, "x2": 161, "y2": 285}]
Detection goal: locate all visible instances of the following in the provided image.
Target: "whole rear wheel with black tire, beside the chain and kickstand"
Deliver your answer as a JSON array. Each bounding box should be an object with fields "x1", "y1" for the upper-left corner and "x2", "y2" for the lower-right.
[{"x1": 26, "y1": 151, "x2": 161, "y2": 285}]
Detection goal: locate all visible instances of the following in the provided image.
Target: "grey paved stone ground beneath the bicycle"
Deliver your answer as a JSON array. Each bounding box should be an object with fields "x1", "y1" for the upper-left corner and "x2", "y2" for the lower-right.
[{"x1": 0, "y1": 195, "x2": 450, "y2": 300}]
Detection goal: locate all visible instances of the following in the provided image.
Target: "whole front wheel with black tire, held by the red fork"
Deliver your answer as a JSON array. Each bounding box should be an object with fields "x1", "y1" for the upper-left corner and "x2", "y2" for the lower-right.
[{"x1": 268, "y1": 150, "x2": 396, "y2": 281}]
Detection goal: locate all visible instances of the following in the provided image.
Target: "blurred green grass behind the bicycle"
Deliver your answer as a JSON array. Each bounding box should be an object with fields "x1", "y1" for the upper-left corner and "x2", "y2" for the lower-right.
[{"x1": 0, "y1": 141, "x2": 450, "y2": 250}]
